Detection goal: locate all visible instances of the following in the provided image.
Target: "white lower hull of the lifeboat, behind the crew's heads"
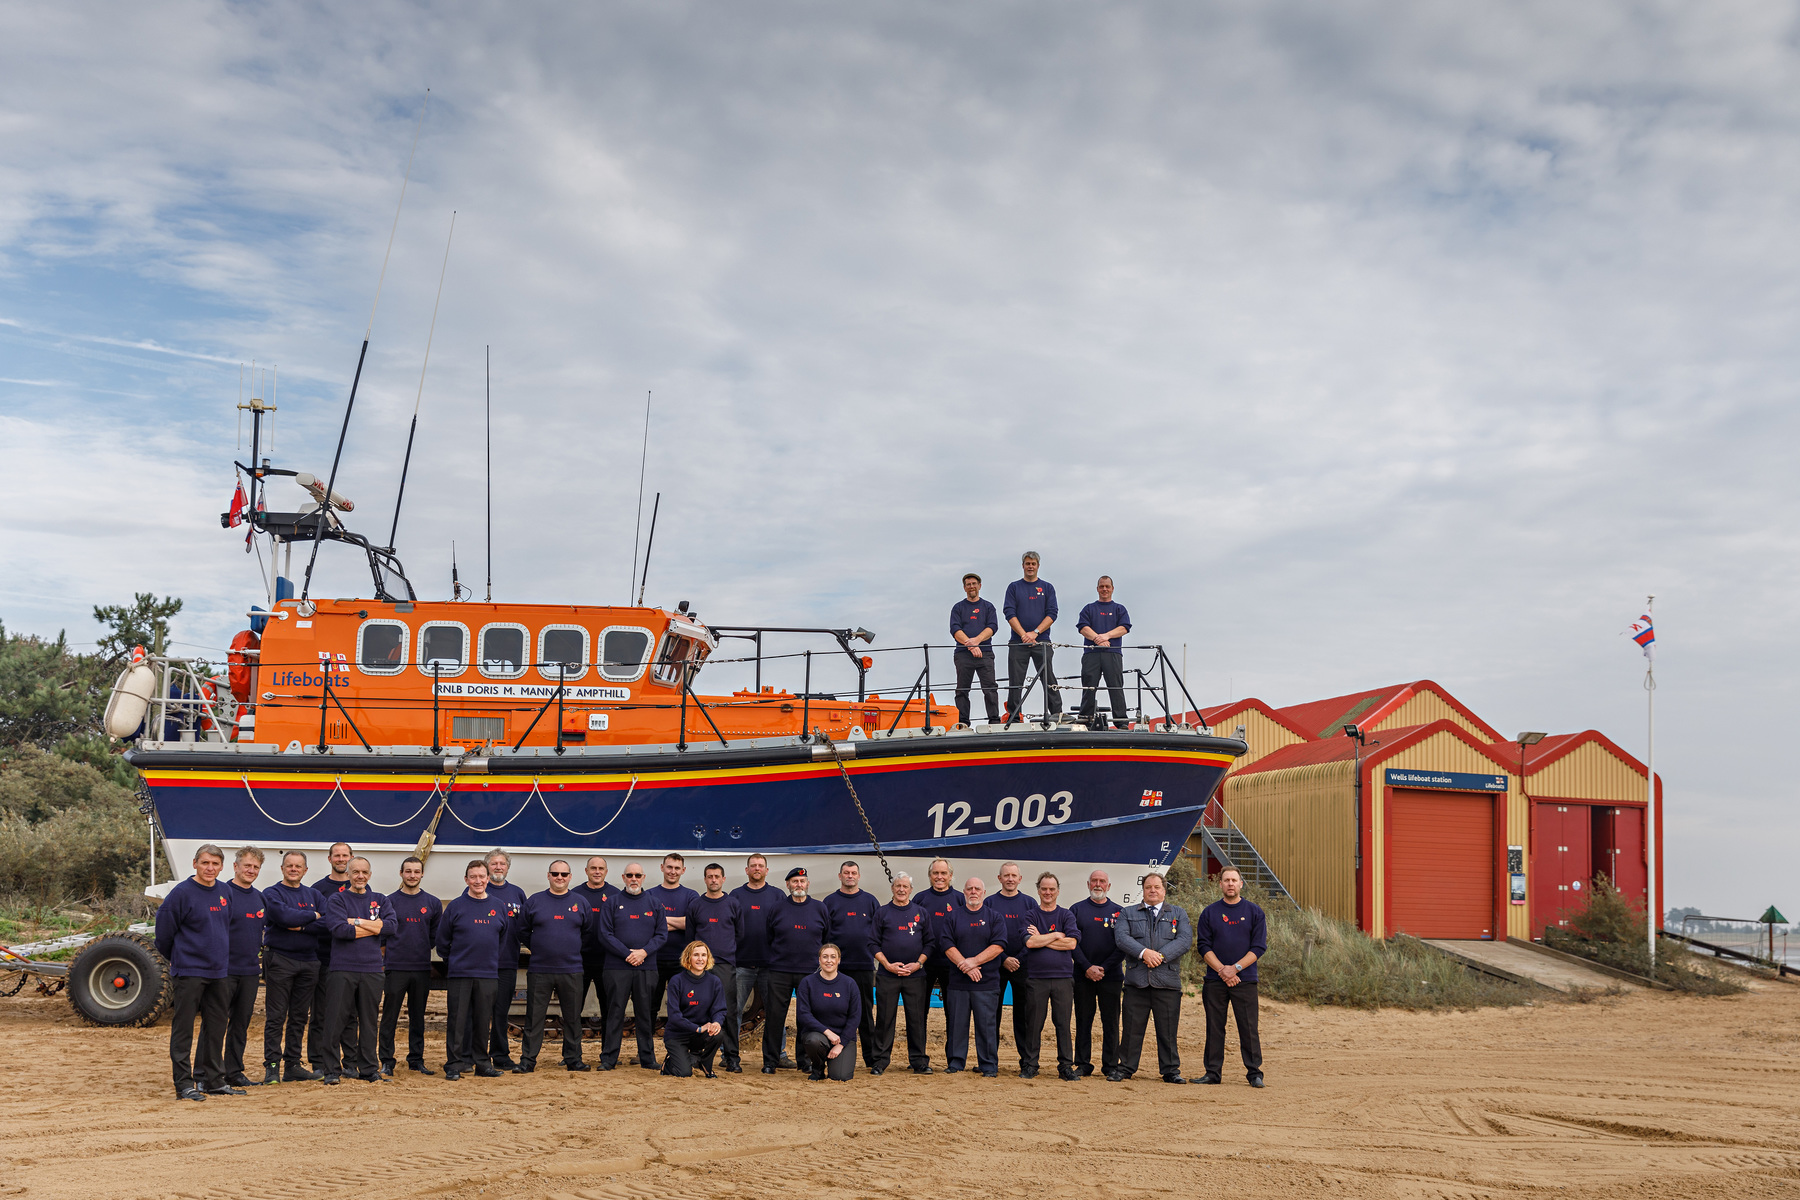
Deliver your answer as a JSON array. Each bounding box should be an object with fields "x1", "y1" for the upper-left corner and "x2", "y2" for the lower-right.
[{"x1": 162, "y1": 838, "x2": 1166, "y2": 907}]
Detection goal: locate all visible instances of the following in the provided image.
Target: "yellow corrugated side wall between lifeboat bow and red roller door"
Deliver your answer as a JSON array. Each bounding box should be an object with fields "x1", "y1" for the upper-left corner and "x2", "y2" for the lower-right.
[{"x1": 1222, "y1": 763, "x2": 1355, "y2": 921}]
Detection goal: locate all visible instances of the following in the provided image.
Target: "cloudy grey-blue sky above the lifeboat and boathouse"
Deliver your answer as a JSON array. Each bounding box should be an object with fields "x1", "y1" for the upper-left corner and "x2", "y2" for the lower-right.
[{"x1": 0, "y1": 0, "x2": 1800, "y2": 916}]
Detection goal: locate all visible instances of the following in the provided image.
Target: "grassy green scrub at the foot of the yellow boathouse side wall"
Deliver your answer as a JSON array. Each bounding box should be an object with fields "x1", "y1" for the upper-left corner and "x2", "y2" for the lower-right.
[{"x1": 1168, "y1": 862, "x2": 1546, "y2": 1009}]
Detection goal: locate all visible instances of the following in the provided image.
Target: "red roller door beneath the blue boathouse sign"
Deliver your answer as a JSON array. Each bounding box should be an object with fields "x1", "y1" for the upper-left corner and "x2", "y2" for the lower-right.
[{"x1": 1386, "y1": 788, "x2": 1498, "y2": 937}]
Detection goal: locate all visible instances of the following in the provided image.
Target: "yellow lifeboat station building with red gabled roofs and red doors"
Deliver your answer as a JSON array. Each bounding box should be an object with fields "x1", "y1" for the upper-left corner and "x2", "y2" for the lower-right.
[{"x1": 1188, "y1": 680, "x2": 1663, "y2": 939}]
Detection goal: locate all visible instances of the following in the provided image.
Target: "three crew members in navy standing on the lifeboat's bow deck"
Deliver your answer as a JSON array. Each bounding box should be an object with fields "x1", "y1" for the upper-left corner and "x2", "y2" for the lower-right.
[{"x1": 950, "y1": 551, "x2": 1130, "y2": 729}]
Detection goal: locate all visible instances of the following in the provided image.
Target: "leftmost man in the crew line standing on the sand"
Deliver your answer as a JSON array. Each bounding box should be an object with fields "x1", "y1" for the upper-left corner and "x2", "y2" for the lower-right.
[{"x1": 157, "y1": 842, "x2": 243, "y2": 1099}]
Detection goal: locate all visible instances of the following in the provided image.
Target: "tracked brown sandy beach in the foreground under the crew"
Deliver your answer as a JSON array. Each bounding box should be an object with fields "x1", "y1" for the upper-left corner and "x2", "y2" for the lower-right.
[{"x1": 0, "y1": 984, "x2": 1800, "y2": 1200}]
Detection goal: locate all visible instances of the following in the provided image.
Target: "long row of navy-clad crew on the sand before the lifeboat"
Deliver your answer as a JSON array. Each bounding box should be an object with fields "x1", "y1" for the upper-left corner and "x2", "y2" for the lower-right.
[{"x1": 157, "y1": 842, "x2": 1267, "y2": 1099}]
